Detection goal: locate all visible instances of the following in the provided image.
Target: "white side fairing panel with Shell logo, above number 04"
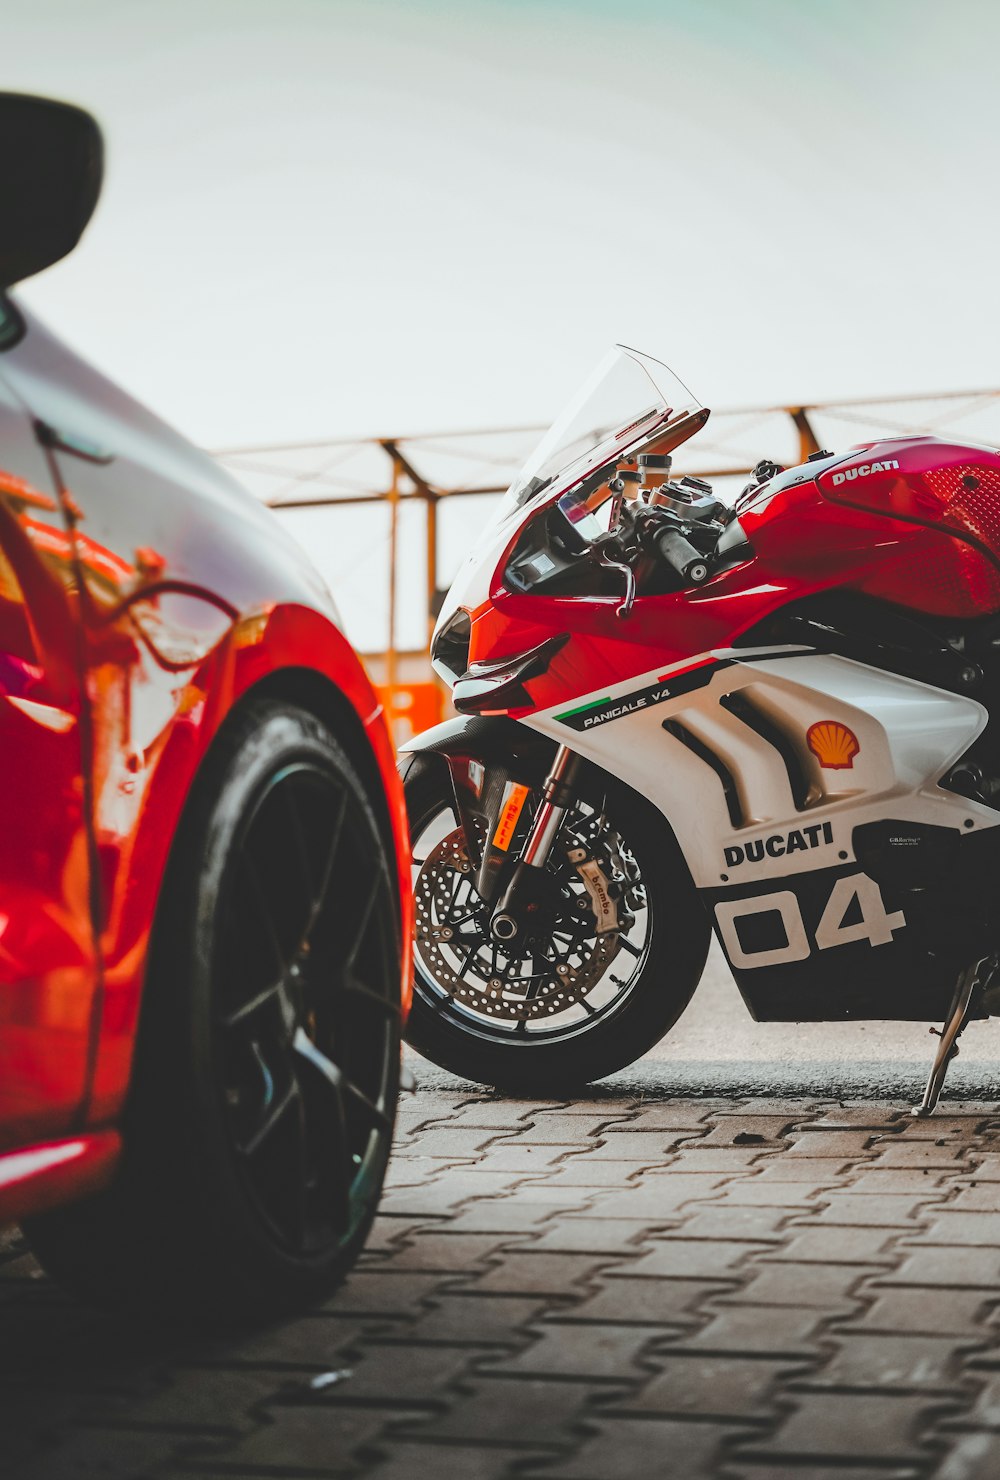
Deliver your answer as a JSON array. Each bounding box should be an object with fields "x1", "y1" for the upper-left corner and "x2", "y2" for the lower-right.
[{"x1": 524, "y1": 648, "x2": 1000, "y2": 889}]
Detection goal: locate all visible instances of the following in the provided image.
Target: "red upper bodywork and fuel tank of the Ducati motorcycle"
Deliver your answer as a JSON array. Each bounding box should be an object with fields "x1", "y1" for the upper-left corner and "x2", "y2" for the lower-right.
[{"x1": 469, "y1": 437, "x2": 1000, "y2": 719}]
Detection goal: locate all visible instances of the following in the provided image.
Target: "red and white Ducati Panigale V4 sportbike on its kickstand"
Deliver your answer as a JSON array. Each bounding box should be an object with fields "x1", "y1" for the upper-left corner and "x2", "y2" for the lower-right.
[{"x1": 402, "y1": 346, "x2": 1000, "y2": 1113}]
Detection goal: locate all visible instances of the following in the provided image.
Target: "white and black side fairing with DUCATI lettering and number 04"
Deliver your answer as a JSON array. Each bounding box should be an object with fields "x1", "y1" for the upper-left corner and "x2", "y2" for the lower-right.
[{"x1": 521, "y1": 647, "x2": 1000, "y2": 1020}]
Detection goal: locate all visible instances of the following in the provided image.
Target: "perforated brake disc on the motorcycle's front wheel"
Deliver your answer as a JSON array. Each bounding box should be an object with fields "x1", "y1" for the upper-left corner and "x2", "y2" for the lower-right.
[{"x1": 414, "y1": 827, "x2": 618, "y2": 1021}]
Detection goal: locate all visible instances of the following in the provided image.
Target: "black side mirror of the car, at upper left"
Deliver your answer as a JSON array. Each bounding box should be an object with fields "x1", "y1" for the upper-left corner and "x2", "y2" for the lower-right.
[{"x1": 0, "y1": 93, "x2": 104, "y2": 289}]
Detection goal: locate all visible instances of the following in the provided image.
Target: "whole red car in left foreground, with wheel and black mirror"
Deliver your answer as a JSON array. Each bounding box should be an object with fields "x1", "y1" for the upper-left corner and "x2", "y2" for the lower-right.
[{"x1": 0, "y1": 95, "x2": 411, "y2": 1317}]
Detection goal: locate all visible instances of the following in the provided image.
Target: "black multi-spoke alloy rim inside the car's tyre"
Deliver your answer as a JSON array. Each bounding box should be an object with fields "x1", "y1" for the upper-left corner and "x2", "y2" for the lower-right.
[{"x1": 213, "y1": 759, "x2": 399, "y2": 1258}]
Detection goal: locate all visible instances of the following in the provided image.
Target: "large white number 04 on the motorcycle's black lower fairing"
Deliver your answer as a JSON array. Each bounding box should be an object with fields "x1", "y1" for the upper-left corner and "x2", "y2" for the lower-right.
[{"x1": 716, "y1": 873, "x2": 907, "y2": 968}]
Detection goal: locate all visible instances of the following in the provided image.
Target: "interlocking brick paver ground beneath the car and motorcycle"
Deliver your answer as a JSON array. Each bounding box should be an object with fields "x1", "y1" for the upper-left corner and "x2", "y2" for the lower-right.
[{"x1": 0, "y1": 1089, "x2": 1000, "y2": 1480}]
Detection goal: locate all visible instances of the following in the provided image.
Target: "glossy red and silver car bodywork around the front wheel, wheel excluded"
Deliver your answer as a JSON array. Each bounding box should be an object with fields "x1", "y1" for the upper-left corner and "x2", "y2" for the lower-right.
[{"x1": 0, "y1": 300, "x2": 411, "y2": 1221}]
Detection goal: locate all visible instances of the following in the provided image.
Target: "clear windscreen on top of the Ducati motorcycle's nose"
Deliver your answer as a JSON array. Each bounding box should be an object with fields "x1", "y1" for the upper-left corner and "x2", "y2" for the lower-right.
[{"x1": 497, "y1": 345, "x2": 700, "y2": 519}]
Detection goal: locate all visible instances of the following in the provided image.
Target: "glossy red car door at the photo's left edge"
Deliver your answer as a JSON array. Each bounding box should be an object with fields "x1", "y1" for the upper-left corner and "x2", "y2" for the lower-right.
[{"x1": 0, "y1": 372, "x2": 98, "y2": 1153}]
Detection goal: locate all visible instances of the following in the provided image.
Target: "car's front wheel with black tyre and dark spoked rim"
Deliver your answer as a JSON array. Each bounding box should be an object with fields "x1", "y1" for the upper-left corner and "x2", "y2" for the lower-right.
[{"x1": 27, "y1": 700, "x2": 401, "y2": 1322}]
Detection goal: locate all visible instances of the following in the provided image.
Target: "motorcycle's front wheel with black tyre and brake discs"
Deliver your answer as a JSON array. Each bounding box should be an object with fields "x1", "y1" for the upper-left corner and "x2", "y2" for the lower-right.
[{"x1": 401, "y1": 753, "x2": 710, "y2": 1095}]
